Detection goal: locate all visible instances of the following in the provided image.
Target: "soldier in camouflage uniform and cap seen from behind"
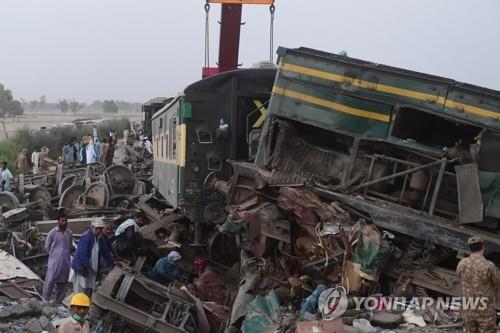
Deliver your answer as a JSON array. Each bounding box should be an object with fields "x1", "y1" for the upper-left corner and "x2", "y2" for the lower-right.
[{"x1": 457, "y1": 236, "x2": 498, "y2": 333}]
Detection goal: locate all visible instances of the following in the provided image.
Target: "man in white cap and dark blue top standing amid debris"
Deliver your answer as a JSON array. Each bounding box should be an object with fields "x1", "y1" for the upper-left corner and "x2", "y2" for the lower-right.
[{"x1": 70, "y1": 218, "x2": 114, "y2": 295}]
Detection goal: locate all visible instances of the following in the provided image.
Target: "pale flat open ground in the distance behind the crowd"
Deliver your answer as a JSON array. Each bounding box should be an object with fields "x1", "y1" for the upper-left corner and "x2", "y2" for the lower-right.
[{"x1": 0, "y1": 111, "x2": 141, "y2": 140}]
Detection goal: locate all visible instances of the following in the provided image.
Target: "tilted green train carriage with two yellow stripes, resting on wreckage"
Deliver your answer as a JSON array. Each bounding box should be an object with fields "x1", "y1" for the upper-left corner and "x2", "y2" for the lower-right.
[{"x1": 256, "y1": 48, "x2": 500, "y2": 253}]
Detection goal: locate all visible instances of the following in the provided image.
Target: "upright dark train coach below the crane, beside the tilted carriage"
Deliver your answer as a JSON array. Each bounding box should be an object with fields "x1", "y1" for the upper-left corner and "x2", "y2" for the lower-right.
[{"x1": 152, "y1": 68, "x2": 276, "y2": 244}]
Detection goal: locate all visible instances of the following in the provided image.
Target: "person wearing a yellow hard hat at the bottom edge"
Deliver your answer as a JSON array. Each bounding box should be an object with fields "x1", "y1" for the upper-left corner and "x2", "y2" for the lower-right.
[{"x1": 57, "y1": 293, "x2": 90, "y2": 333}]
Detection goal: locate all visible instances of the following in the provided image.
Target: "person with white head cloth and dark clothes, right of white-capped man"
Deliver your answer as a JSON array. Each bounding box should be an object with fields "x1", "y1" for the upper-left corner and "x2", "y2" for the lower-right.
[{"x1": 115, "y1": 213, "x2": 144, "y2": 261}]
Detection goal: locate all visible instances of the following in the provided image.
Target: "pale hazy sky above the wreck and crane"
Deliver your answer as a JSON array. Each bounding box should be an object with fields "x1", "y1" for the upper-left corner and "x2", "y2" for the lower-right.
[{"x1": 0, "y1": 0, "x2": 500, "y2": 102}]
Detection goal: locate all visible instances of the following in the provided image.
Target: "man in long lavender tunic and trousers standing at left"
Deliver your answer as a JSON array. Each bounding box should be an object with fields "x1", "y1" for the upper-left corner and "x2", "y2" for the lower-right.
[{"x1": 42, "y1": 209, "x2": 73, "y2": 304}]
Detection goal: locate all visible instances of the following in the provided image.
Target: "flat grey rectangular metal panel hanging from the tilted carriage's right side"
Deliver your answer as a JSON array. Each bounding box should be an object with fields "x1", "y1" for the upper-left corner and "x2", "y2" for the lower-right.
[{"x1": 455, "y1": 164, "x2": 483, "y2": 224}]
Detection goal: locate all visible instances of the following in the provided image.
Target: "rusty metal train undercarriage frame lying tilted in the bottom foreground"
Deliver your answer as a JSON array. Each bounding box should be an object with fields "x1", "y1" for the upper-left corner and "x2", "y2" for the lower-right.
[{"x1": 93, "y1": 264, "x2": 228, "y2": 333}]
